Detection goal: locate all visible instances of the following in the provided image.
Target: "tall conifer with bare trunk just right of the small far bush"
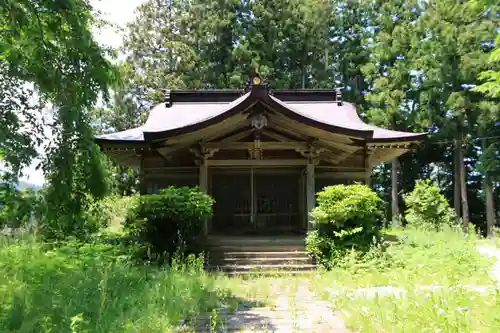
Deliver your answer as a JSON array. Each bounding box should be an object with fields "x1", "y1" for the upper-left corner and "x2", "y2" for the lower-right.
[{"x1": 412, "y1": 0, "x2": 499, "y2": 227}]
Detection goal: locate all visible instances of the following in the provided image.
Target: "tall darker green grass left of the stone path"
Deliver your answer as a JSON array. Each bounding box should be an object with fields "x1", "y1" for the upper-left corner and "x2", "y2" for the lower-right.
[{"x1": 0, "y1": 238, "x2": 230, "y2": 333}]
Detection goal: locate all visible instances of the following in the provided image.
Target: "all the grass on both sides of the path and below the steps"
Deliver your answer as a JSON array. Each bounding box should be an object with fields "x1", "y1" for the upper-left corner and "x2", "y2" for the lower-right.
[{"x1": 0, "y1": 224, "x2": 500, "y2": 333}]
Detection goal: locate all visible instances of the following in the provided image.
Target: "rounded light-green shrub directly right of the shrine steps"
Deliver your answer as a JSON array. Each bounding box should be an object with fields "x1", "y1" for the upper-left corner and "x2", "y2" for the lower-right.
[{"x1": 306, "y1": 184, "x2": 384, "y2": 266}]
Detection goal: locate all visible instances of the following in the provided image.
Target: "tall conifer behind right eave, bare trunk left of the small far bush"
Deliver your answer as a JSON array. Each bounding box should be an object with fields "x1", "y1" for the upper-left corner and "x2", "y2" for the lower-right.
[{"x1": 362, "y1": 0, "x2": 429, "y2": 220}]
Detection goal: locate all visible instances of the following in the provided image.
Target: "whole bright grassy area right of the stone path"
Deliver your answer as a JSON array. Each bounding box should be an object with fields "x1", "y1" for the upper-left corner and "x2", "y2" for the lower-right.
[{"x1": 316, "y1": 229, "x2": 500, "y2": 333}]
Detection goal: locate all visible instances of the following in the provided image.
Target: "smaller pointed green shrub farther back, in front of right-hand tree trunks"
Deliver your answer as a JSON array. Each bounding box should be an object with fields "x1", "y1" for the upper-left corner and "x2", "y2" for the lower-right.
[{"x1": 404, "y1": 180, "x2": 456, "y2": 230}]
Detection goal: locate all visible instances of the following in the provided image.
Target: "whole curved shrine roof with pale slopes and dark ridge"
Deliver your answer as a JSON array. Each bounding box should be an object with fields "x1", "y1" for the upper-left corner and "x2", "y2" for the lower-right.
[{"x1": 96, "y1": 75, "x2": 426, "y2": 143}]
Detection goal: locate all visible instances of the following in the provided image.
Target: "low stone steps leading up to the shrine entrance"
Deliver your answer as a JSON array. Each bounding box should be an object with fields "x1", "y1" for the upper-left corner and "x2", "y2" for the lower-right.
[{"x1": 206, "y1": 236, "x2": 316, "y2": 274}]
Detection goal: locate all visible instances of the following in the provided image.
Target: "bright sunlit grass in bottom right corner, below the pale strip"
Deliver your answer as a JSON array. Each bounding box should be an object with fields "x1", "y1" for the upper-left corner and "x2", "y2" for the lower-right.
[{"x1": 336, "y1": 288, "x2": 500, "y2": 333}]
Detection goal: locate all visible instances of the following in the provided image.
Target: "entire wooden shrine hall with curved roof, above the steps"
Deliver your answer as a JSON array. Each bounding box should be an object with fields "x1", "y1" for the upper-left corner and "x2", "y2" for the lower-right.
[{"x1": 95, "y1": 73, "x2": 425, "y2": 236}]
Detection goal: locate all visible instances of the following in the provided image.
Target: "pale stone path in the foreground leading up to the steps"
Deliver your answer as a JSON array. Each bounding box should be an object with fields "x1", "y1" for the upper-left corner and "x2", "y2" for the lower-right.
[{"x1": 179, "y1": 279, "x2": 348, "y2": 333}]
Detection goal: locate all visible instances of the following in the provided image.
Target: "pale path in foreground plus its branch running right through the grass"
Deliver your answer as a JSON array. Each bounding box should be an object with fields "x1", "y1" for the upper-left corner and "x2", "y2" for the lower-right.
[{"x1": 179, "y1": 246, "x2": 500, "y2": 333}]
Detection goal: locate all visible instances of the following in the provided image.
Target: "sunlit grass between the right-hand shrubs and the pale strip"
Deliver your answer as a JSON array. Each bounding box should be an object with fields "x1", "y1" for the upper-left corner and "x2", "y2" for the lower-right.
[{"x1": 318, "y1": 224, "x2": 493, "y2": 288}]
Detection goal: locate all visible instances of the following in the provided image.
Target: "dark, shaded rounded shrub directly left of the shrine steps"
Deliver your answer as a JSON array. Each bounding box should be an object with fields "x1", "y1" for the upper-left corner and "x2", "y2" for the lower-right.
[{"x1": 124, "y1": 187, "x2": 213, "y2": 255}]
